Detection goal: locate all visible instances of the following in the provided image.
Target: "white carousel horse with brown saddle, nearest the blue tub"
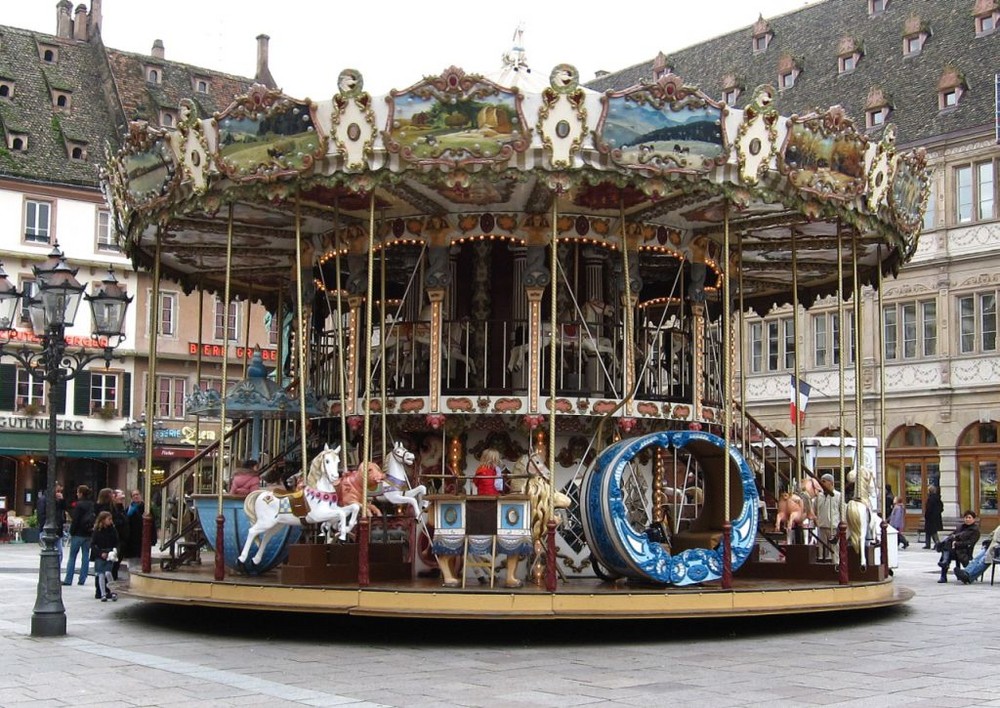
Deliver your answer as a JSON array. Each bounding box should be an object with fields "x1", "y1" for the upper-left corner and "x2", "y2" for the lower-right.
[{"x1": 239, "y1": 445, "x2": 361, "y2": 563}]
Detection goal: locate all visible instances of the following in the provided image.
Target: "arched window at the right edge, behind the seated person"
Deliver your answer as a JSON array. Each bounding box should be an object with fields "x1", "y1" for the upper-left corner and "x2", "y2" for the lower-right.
[{"x1": 958, "y1": 420, "x2": 1000, "y2": 530}]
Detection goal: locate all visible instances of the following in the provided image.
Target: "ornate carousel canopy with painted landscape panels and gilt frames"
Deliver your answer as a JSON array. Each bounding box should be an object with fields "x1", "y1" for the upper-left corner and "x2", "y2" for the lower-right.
[{"x1": 106, "y1": 65, "x2": 928, "y2": 311}]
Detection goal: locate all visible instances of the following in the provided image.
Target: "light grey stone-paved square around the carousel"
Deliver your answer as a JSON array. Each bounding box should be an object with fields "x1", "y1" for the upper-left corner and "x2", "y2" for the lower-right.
[{"x1": 0, "y1": 543, "x2": 1000, "y2": 708}]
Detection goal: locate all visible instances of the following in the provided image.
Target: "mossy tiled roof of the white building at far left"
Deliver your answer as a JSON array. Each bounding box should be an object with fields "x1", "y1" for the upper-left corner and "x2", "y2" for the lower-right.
[{"x1": 0, "y1": 27, "x2": 117, "y2": 188}]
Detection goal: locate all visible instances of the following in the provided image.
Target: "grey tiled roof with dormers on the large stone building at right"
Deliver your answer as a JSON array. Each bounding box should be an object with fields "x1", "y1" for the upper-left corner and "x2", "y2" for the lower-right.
[{"x1": 587, "y1": 0, "x2": 1000, "y2": 144}]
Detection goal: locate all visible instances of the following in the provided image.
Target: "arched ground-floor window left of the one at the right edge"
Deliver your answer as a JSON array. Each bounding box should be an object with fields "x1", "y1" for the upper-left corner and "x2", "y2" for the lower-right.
[{"x1": 885, "y1": 425, "x2": 941, "y2": 517}]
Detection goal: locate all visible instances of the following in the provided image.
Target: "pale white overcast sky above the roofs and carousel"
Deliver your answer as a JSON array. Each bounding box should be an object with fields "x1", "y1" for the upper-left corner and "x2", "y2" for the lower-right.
[{"x1": 0, "y1": 0, "x2": 820, "y2": 100}]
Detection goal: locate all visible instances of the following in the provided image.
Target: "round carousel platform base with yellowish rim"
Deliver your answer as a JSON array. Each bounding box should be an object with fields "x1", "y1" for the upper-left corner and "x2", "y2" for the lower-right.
[{"x1": 126, "y1": 553, "x2": 913, "y2": 620}]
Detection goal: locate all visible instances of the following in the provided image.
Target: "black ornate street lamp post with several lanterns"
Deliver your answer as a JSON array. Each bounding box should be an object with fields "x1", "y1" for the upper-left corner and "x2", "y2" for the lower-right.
[{"x1": 0, "y1": 243, "x2": 132, "y2": 637}]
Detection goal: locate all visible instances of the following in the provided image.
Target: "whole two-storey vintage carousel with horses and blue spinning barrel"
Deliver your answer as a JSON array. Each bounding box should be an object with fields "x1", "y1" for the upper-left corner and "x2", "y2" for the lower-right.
[{"x1": 106, "y1": 55, "x2": 927, "y2": 618}]
